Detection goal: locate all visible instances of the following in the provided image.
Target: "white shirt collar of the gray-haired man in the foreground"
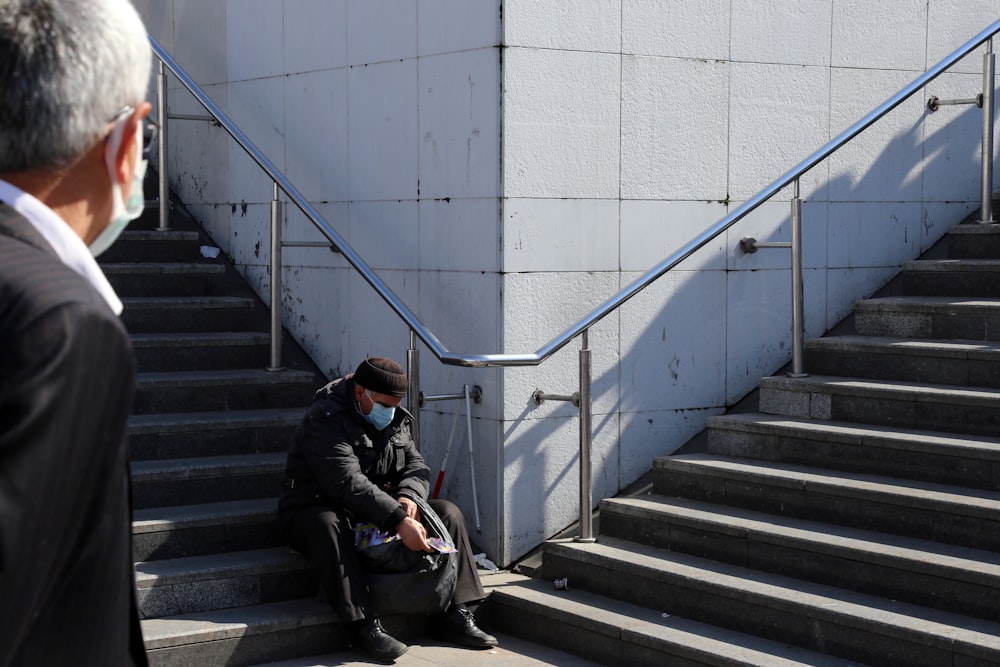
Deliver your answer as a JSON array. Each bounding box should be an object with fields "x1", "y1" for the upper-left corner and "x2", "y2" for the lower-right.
[{"x1": 0, "y1": 180, "x2": 123, "y2": 315}]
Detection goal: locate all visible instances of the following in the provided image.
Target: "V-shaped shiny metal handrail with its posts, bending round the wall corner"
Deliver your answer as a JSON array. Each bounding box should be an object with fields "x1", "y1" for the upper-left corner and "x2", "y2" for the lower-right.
[{"x1": 149, "y1": 20, "x2": 1000, "y2": 541}]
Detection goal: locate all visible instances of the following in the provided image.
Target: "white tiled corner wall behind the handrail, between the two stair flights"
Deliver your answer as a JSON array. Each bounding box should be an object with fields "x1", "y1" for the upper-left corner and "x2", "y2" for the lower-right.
[{"x1": 136, "y1": 0, "x2": 996, "y2": 563}]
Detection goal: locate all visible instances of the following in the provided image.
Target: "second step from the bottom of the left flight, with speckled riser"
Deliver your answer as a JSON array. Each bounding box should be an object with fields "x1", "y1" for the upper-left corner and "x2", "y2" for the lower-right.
[{"x1": 135, "y1": 547, "x2": 317, "y2": 618}]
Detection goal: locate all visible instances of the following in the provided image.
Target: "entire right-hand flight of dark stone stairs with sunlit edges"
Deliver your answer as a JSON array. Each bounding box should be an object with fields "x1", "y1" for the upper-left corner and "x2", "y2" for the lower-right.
[{"x1": 489, "y1": 224, "x2": 1000, "y2": 667}]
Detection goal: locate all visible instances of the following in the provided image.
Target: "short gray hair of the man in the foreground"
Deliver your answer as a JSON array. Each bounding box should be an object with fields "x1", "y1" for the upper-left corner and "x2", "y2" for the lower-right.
[{"x1": 0, "y1": 0, "x2": 152, "y2": 172}]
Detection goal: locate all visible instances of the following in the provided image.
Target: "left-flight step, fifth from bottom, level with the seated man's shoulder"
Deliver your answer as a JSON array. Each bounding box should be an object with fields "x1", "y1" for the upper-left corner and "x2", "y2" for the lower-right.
[{"x1": 128, "y1": 407, "x2": 305, "y2": 461}]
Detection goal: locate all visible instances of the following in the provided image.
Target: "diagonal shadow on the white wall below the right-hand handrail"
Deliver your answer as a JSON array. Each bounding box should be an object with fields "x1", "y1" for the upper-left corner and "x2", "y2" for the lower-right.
[{"x1": 504, "y1": 92, "x2": 981, "y2": 559}]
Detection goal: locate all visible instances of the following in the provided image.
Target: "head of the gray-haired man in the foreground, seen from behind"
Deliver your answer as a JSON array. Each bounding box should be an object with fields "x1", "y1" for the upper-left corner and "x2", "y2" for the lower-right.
[{"x1": 0, "y1": 0, "x2": 152, "y2": 249}]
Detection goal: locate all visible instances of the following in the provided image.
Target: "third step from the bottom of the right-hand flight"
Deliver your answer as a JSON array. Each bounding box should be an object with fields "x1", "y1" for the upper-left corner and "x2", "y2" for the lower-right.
[{"x1": 601, "y1": 495, "x2": 1000, "y2": 620}]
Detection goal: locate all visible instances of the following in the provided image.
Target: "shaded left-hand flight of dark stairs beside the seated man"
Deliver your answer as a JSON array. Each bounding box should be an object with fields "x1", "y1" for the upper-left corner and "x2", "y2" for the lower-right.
[{"x1": 100, "y1": 196, "x2": 352, "y2": 667}]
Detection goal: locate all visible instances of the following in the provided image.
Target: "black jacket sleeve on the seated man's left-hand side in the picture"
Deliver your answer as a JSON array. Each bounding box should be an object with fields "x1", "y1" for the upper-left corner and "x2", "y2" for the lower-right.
[{"x1": 297, "y1": 402, "x2": 399, "y2": 526}]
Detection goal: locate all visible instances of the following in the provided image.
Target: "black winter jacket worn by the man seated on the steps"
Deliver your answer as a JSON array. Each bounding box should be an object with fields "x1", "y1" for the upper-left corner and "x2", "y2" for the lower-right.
[{"x1": 278, "y1": 378, "x2": 430, "y2": 532}]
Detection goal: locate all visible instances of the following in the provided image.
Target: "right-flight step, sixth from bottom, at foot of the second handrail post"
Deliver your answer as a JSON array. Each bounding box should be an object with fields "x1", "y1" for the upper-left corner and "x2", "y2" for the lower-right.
[{"x1": 759, "y1": 375, "x2": 1000, "y2": 436}]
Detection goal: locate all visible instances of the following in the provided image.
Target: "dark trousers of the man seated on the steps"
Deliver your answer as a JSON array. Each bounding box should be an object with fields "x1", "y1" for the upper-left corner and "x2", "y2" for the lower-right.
[{"x1": 281, "y1": 499, "x2": 486, "y2": 623}]
